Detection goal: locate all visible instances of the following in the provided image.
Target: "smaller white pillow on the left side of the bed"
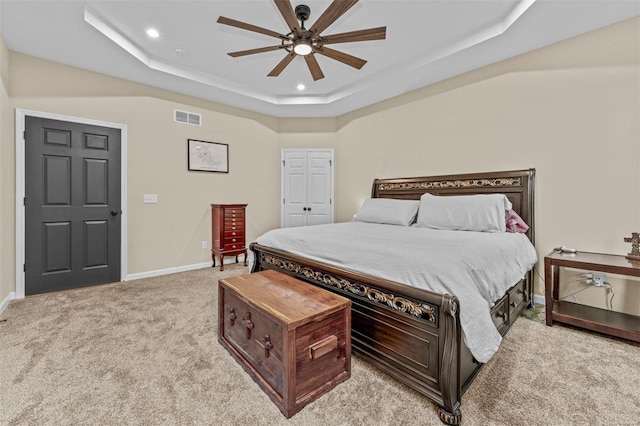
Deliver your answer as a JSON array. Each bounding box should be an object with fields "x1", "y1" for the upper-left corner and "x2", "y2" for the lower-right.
[{"x1": 353, "y1": 198, "x2": 420, "y2": 226}]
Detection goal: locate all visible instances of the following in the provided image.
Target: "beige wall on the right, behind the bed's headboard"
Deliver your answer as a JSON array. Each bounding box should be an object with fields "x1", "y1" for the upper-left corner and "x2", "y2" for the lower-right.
[{"x1": 336, "y1": 19, "x2": 640, "y2": 313}]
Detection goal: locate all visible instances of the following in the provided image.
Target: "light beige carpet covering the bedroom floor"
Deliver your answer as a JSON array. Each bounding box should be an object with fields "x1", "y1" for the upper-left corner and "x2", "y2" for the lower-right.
[{"x1": 0, "y1": 265, "x2": 640, "y2": 425}]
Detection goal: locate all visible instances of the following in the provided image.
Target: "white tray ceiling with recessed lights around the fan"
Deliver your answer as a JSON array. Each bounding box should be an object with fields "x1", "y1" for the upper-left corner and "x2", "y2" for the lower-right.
[{"x1": 0, "y1": 0, "x2": 640, "y2": 117}]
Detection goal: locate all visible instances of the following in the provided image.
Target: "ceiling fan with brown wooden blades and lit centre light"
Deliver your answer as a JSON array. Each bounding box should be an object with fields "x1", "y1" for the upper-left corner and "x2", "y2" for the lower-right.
[{"x1": 217, "y1": 0, "x2": 387, "y2": 81}]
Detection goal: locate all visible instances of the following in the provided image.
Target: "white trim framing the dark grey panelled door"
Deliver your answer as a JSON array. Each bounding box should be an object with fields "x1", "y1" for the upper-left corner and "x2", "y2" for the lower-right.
[{"x1": 15, "y1": 108, "x2": 128, "y2": 299}]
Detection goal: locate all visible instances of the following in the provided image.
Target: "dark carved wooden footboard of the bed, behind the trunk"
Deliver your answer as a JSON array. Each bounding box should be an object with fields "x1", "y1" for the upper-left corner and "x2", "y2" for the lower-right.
[{"x1": 250, "y1": 243, "x2": 468, "y2": 425}]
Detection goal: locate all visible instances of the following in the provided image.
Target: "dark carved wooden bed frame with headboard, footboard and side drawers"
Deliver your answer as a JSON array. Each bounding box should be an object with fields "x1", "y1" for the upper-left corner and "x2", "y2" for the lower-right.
[{"x1": 250, "y1": 169, "x2": 535, "y2": 425}]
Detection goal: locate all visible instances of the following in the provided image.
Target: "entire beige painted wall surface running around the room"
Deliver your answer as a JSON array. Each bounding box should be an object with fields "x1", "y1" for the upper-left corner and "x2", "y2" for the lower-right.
[{"x1": 0, "y1": 19, "x2": 640, "y2": 312}]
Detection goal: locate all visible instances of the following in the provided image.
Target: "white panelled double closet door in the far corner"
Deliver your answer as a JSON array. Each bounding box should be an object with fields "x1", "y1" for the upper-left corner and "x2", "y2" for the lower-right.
[{"x1": 282, "y1": 150, "x2": 333, "y2": 228}]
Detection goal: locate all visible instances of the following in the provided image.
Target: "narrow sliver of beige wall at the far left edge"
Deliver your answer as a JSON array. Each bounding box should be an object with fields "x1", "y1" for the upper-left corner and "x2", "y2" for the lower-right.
[{"x1": 0, "y1": 35, "x2": 15, "y2": 305}]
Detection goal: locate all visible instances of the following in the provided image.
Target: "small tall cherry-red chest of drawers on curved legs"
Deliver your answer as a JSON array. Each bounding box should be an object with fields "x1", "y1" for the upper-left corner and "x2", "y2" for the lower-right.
[{"x1": 211, "y1": 204, "x2": 247, "y2": 271}]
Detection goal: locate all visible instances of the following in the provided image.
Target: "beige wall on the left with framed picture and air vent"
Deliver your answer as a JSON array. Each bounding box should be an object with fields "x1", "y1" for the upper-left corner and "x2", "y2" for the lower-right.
[{"x1": 3, "y1": 53, "x2": 280, "y2": 274}]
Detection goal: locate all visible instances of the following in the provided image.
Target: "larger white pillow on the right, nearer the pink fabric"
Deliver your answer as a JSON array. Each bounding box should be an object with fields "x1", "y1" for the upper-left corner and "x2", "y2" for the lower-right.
[{"x1": 416, "y1": 193, "x2": 511, "y2": 232}]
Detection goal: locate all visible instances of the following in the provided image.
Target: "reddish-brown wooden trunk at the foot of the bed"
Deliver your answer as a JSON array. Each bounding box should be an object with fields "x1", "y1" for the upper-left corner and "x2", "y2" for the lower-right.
[{"x1": 218, "y1": 270, "x2": 351, "y2": 418}]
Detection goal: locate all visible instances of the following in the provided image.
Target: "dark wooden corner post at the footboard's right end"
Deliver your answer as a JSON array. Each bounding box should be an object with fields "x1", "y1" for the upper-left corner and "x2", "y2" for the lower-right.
[{"x1": 438, "y1": 294, "x2": 462, "y2": 425}]
